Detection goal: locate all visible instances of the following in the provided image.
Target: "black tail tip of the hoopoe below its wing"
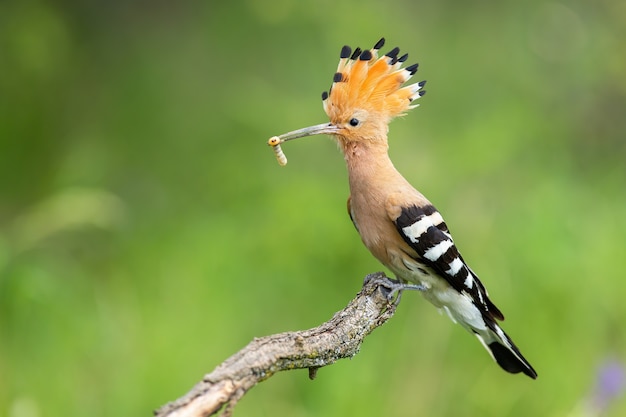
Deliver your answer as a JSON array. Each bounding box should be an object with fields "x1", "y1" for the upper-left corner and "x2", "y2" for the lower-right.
[{"x1": 472, "y1": 320, "x2": 537, "y2": 379}]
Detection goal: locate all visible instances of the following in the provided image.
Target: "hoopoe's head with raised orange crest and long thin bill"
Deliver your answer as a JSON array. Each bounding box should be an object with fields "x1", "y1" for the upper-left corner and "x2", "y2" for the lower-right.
[{"x1": 270, "y1": 38, "x2": 426, "y2": 150}]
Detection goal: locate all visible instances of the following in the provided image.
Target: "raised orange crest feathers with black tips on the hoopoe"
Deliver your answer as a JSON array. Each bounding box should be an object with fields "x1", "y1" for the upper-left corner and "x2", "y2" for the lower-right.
[{"x1": 322, "y1": 38, "x2": 426, "y2": 122}]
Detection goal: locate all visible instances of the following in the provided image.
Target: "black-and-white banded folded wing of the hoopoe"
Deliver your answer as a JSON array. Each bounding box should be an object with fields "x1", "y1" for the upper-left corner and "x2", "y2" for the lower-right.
[{"x1": 388, "y1": 204, "x2": 504, "y2": 320}]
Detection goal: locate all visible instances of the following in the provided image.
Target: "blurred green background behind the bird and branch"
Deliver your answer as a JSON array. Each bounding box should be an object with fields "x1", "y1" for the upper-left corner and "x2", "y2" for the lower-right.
[{"x1": 0, "y1": 0, "x2": 626, "y2": 417}]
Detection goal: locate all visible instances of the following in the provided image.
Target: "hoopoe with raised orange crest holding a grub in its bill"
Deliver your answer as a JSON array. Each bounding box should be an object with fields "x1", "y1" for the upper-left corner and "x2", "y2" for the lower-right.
[{"x1": 269, "y1": 38, "x2": 537, "y2": 379}]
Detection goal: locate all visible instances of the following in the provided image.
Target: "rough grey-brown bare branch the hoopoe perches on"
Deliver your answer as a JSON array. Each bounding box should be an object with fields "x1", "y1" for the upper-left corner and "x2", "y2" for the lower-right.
[{"x1": 155, "y1": 272, "x2": 402, "y2": 417}]
